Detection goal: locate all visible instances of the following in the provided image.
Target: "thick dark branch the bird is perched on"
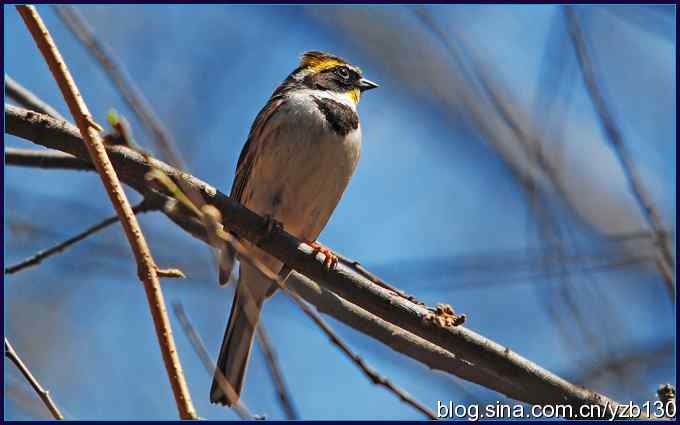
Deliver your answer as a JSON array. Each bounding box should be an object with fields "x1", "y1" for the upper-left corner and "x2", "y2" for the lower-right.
[{"x1": 5, "y1": 105, "x2": 617, "y2": 416}]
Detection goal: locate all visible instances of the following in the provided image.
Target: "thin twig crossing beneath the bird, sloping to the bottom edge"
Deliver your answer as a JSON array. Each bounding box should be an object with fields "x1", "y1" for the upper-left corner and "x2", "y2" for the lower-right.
[{"x1": 202, "y1": 205, "x2": 437, "y2": 419}]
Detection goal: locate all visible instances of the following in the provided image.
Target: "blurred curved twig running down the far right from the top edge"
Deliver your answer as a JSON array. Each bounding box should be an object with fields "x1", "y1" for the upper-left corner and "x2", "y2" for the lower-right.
[{"x1": 564, "y1": 6, "x2": 675, "y2": 302}]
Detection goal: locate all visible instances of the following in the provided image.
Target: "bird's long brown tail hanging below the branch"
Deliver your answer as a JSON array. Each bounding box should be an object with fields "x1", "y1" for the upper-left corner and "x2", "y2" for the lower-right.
[{"x1": 210, "y1": 263, "x2": 272, "y2": 406}]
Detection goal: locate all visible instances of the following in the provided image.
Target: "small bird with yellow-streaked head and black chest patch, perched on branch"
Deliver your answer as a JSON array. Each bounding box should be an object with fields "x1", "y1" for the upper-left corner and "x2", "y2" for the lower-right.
[{"x1": 210, "y1": 51, "x2": 378, "y2": 406}]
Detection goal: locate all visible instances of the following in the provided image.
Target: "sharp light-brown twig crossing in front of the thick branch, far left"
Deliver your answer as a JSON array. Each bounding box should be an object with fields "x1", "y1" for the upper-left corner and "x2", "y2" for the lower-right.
[{"x1": 16, "y1": 6, "x2": 197, "y2": 419}]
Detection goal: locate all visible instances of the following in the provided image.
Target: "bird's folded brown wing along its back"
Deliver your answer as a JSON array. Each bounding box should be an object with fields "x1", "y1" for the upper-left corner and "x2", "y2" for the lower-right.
[{"x1": 230, "y1": 95, "x2": 285, "y2": 202}]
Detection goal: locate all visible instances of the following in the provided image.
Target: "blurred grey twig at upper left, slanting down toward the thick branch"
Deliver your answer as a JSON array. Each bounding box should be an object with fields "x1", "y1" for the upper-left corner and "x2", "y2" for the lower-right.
[{"x1": 54, "y1": 6, "x2": 185, "y2": 169}]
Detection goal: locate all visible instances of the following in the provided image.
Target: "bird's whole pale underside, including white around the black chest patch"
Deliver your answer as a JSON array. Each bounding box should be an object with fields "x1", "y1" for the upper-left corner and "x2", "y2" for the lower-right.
[{"x1": 242, "y1": 90, "x2": 361, "y2": 241}]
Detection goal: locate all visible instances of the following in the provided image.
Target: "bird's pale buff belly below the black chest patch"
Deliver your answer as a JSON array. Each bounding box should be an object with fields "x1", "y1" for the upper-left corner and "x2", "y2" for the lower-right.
[{"x1": 243, "y1": 124, "x2": 361, "y2": 241}]
